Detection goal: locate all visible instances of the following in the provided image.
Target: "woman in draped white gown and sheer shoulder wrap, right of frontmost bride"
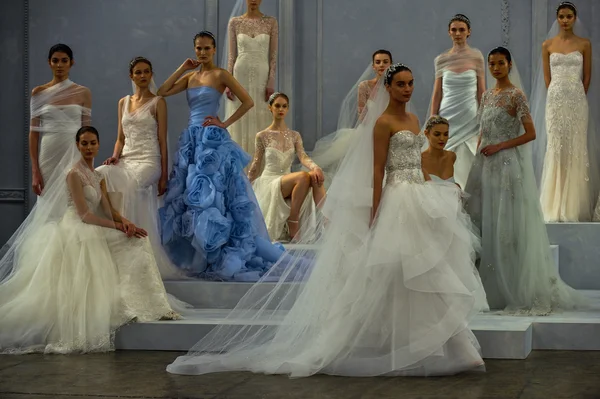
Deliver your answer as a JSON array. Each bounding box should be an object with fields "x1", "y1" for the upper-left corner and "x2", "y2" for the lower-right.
[{"x1": 428, "y1": 14, "x2": 485, "y2": 187}]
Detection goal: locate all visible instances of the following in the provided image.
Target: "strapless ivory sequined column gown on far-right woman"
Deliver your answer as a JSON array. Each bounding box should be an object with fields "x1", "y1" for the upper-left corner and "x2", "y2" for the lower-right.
[{"x1": 540, "y1": 51, "x2": 592, "y2": 222}]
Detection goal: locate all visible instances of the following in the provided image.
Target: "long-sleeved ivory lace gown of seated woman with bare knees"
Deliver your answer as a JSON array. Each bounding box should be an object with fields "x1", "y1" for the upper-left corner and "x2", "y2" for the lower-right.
[{"x1": 248, "y1": 130, "x2": 317, "y2": 241}]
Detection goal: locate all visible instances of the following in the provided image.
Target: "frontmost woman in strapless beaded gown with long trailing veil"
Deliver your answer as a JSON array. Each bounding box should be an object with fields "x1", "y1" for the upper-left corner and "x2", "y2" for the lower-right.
[{"x1": 167, "y1": 64, "x2": 484, "y2": 377}]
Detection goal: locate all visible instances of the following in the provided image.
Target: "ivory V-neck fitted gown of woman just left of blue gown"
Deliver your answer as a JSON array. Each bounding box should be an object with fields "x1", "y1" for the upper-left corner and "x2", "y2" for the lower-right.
[{"x1": 96, "y1": 96, "x2": 184, "y2": 280}]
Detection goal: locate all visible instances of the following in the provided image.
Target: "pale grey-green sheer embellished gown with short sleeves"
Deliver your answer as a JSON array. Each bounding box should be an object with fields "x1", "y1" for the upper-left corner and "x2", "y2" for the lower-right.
[{"x1": 465, "y1": 87, "x2": 581, "y2": 315}]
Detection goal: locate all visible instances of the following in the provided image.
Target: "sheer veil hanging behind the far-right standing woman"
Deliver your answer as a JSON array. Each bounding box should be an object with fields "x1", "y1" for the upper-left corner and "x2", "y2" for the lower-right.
[{"x1": 529, "y1": 17, "x2": 600, "y2": 206}]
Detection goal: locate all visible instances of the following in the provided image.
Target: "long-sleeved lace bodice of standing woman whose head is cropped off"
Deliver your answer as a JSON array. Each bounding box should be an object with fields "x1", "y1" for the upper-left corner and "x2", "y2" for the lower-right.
[{"x1": 227, "y1": 15, "x2": 279, "y2": 88}]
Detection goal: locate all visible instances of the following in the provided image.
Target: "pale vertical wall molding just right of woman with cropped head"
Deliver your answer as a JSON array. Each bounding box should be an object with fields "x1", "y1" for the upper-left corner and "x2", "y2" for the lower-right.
[{"x1": 277, "y1": 0, "x2": 296, "y2": 128}]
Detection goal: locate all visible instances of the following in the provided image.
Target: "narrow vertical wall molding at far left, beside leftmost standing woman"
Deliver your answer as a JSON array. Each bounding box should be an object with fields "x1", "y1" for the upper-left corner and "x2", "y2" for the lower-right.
[{"x1": 23, "y1": 0, "x2": 31, "y2": 212}]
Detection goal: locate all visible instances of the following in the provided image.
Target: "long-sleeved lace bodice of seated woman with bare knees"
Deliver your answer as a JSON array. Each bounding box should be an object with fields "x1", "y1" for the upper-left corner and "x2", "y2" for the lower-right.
[{"x1": 248, "y1": 129, "x2": 318, "y2": 181}]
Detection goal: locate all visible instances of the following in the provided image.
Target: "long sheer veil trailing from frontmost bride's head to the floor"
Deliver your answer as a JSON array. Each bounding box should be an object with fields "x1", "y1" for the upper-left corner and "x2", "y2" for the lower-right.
[{"x1": 167, "y1": 79, "x2": 389, "y2": 374}]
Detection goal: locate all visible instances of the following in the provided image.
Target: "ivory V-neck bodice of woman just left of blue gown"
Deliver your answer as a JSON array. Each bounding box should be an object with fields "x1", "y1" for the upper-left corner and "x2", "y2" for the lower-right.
[{"x1": 121, "y1": 96, "x2": 160, "y2": 161}]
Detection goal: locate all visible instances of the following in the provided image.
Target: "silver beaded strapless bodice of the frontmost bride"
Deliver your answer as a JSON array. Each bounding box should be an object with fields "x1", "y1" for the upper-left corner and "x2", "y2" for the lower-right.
[{"x1": 385, "y1": 130, "x2": 425, "y2": 184}]
